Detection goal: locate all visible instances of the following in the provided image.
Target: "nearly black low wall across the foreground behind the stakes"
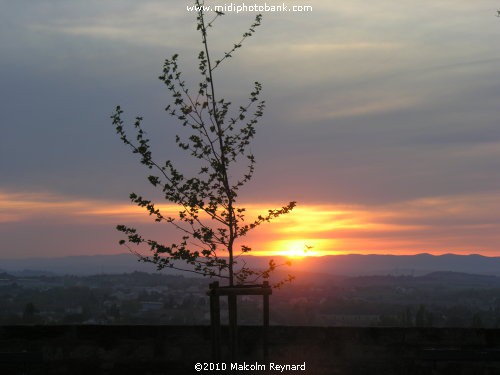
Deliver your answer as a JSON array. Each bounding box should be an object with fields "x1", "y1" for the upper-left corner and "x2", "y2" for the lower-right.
[{"x1": 0, "y1": 326, "x2": 500, "y2": 375}]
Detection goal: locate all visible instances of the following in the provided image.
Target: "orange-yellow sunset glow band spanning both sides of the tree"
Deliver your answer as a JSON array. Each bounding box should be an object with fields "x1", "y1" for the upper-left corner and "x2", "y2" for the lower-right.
[{"x1": 0, "y1": 190, "x2": 500, "y2": 259}]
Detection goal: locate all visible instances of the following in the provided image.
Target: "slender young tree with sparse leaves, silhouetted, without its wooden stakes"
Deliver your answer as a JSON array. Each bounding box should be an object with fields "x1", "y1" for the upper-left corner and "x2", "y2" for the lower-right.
[{"x1": 111, "y1": 0, "x2": 296, "y2": 286}]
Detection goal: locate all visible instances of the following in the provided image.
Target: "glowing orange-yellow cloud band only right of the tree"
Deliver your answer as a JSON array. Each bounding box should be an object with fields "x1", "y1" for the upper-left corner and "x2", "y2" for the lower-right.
[{"x1": 240, "y1": 191, "x2": 500, "y2": 256}]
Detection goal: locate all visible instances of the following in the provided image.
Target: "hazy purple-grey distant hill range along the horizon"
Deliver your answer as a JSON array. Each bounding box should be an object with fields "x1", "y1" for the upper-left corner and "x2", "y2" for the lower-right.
[{"x1": 0, "y1": 254, "x2": 500, "y2": 276}]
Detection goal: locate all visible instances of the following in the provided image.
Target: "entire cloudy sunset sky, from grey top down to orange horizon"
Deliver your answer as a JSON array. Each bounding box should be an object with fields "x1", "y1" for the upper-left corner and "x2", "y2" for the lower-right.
[{"x1": 0, "y1": 0, "x2": 500, "y2": 258}]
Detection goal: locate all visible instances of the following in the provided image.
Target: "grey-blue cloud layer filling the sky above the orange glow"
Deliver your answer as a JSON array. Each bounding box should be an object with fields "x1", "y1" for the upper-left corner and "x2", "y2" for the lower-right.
[{"x1": 0, "y1": 0, "x2": 500, "y2": 209}]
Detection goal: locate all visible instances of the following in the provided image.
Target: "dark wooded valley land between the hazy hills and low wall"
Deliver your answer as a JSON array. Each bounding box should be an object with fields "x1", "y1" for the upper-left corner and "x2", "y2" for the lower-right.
[{"x1": 0, "y1": 272, "x2": 500, "y2": 328}]
